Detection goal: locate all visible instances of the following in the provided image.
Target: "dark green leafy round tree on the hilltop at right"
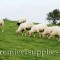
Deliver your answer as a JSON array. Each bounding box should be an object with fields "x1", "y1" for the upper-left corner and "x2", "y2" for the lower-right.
[{"x1": 47, "y1": 9, "x2": 60, "y2": 24}]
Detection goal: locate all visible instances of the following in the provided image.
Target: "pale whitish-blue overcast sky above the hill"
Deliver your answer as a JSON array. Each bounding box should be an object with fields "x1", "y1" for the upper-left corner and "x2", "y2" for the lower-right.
[{"x1": 0, "y1": 0, "x2": 60, "y2": 24}]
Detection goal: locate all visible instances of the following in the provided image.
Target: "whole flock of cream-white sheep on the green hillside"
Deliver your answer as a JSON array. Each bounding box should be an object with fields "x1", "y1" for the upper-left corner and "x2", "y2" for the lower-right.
[{"x1": 0, "y1": 18, "x2": 60, "y2": 41}]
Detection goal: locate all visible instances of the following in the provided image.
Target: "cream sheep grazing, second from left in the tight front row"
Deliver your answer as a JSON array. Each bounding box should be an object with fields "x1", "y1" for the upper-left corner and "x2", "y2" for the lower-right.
[{"x1": 28, "y1": 24, "x2": 47, "y2": 37}]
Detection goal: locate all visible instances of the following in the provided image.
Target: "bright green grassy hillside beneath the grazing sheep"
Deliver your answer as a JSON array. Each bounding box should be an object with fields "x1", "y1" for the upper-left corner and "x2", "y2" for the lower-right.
[{"x1": 0, "y1": 21, "x2": 60, "y2": 60}]
